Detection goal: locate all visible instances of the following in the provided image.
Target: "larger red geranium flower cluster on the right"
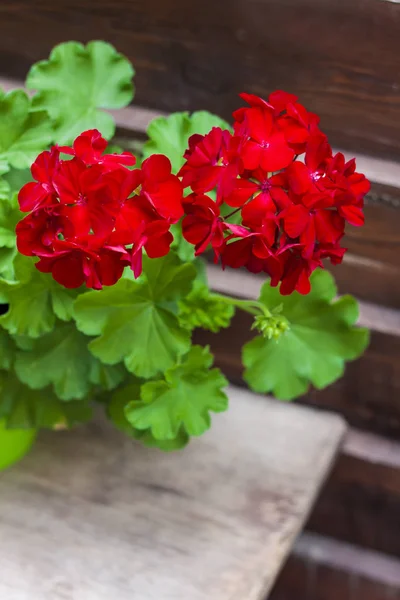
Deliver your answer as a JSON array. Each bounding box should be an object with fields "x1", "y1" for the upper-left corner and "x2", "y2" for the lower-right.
[{"x1": 179, "y1": 91, "x2": 370, "y2": 295}]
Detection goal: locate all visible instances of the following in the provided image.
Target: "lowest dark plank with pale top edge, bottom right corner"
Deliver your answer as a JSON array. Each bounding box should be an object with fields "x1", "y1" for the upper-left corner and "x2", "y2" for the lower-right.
[{"x1": 269, "y1": 534, "x2": 400, "y2": 600}]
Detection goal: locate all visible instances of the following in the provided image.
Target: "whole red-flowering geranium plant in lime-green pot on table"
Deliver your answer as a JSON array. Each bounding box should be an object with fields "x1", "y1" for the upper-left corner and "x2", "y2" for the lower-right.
[{"x1": 0, "y1": 41, "x2": 369, "y2": 468}]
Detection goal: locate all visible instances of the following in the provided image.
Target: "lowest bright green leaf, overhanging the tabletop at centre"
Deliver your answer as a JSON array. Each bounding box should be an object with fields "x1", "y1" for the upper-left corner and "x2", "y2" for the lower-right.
[{"x1": 126, "y1": 346, "x2": 228, "y2": 440}]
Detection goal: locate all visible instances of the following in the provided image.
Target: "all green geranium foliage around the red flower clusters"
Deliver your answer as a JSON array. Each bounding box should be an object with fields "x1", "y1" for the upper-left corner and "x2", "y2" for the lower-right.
[{"x1": 0, "y1": 41, "x2": 368, "y2": 451}]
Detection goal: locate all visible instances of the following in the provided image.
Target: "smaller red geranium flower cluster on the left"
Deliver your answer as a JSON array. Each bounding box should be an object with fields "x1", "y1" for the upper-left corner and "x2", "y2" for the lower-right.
[{"x1": 16, "y1": 130, "x2": 183, "y2": 289}]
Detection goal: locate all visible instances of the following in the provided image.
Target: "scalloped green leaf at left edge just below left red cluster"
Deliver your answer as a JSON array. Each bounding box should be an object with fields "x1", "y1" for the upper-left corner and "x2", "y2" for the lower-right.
[{"x1": 0, "y1": 254, "x2": 78, "y2": 338}]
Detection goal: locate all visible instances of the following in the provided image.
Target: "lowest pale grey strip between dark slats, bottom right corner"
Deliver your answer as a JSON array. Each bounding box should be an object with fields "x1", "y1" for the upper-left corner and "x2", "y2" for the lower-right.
[{"x1": 293, "y1": 533, "x2": 400, "y2": 588}]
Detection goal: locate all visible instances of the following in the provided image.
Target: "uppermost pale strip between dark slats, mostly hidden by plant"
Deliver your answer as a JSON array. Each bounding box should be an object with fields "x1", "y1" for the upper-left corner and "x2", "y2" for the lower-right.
[{"x1": 0, "y1": 77, "x2": 400, "y2": 187}]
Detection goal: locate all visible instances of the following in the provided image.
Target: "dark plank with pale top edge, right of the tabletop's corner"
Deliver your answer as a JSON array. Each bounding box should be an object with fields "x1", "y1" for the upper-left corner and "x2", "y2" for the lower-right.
[{"x1": 307, "y1": 430, "x2": 400, "y2": 558}]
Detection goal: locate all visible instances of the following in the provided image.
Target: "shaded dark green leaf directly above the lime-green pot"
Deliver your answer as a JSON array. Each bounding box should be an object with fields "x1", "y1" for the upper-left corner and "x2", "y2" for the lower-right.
[{"x1": 0, "y1": 372, "x2": 92, "y2": 429}]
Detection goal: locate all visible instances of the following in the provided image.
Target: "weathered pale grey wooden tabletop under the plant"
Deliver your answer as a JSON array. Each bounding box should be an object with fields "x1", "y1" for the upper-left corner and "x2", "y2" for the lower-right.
[{"x1": 0, "y1": 388, "x2": 345, "y2": 600}]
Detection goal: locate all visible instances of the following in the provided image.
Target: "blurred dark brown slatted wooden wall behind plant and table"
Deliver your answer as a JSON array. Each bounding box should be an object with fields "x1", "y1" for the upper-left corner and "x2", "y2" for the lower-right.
[{"x1": 0, "y1": 0, "x2": 400, "y2": 600}]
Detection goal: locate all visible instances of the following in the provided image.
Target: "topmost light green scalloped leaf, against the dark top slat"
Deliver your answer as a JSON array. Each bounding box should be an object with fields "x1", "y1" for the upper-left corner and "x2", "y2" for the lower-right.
[{"x1": 27, "y1": 41, "x2": 134, "y2": 144}]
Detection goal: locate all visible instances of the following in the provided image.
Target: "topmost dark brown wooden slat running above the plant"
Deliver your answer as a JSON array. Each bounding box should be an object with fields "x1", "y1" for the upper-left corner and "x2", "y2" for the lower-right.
[{"x1": 0, "y1": 0, "x2": 400, "y2": 157}]
